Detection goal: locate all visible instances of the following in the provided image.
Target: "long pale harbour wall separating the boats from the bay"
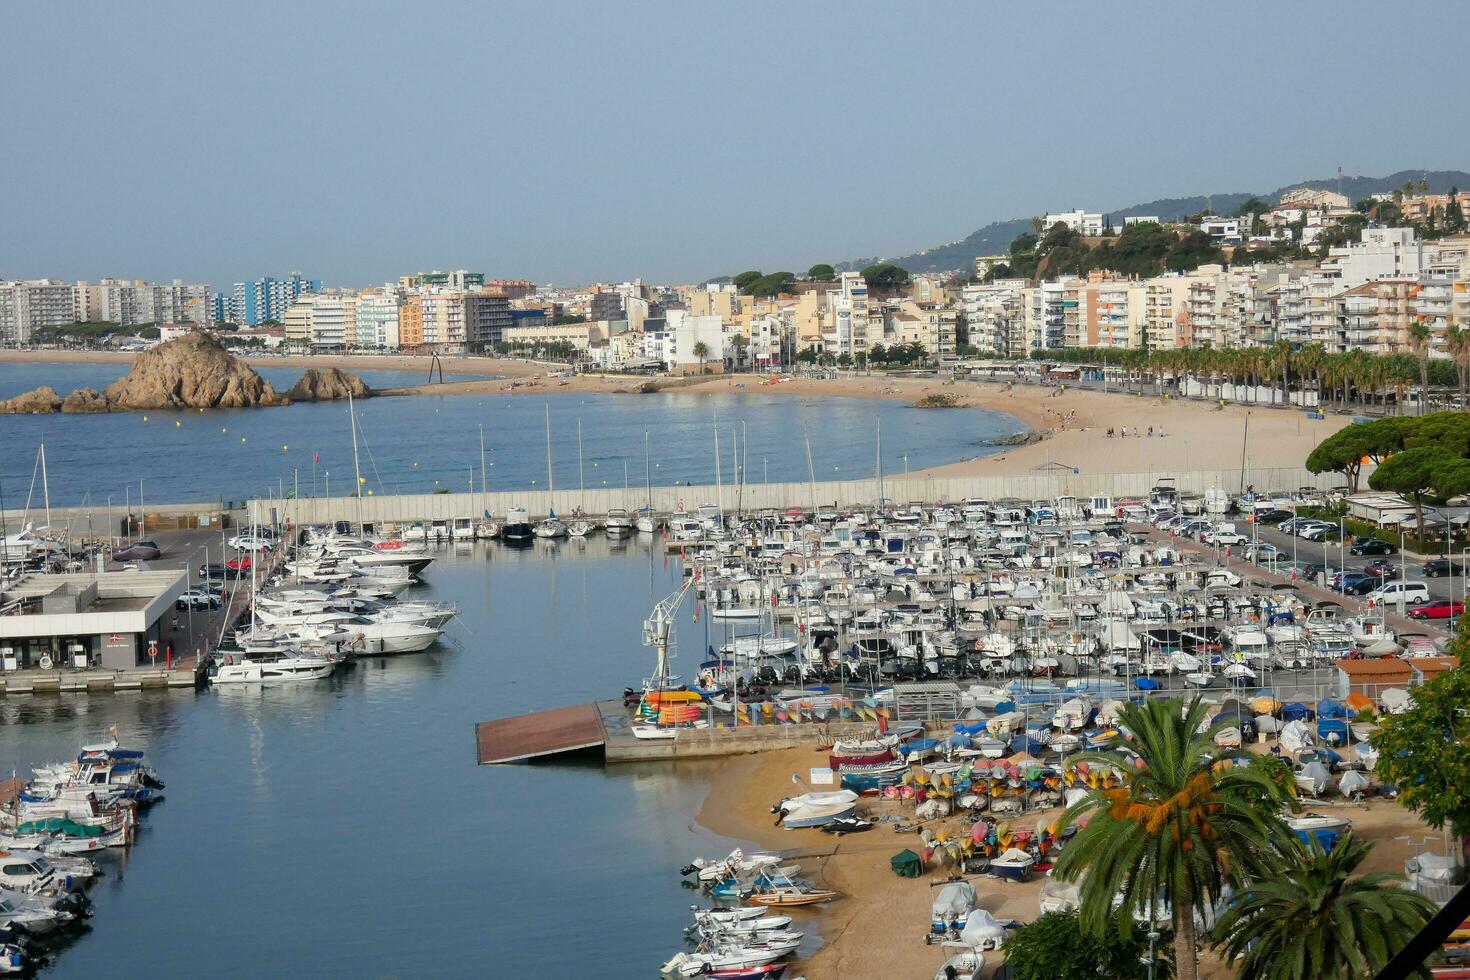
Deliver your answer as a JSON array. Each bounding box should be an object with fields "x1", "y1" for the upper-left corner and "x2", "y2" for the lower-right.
[{"x1": 247, "y1": 467, "x2": 1341, "y2": 525}]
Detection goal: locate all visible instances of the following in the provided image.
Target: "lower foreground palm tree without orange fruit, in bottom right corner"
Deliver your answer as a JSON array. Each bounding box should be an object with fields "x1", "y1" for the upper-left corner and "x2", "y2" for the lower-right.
[{"x1": 1214, "y1": 833, "x2": 1438, "y2": 980}]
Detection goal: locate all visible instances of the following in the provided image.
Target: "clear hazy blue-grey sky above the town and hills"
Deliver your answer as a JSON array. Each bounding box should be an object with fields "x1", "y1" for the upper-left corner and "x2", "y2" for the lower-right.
[{"x1": 0, "y1": 0, "x2": 1470, "y2": 289}]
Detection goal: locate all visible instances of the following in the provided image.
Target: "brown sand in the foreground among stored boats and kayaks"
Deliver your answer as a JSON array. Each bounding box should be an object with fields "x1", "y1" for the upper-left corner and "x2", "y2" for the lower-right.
[{"x1": 698, "y1": 748, "x2": 1439, "y2": 980}]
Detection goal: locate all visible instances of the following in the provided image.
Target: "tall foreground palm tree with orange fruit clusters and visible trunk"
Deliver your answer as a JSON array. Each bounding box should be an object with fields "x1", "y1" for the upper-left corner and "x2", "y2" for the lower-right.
[{"x1": 1057, "y1": 698, "x2": 1289, "y2": 980}]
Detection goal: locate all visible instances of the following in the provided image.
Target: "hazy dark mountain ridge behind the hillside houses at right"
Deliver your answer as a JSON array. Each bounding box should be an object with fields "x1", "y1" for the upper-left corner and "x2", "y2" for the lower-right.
[{"x1": 838, "y1": 170, "x2": 1470, "y2": 273}]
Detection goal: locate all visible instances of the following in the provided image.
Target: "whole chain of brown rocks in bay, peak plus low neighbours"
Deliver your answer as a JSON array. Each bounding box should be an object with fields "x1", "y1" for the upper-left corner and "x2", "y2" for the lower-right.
[{"x1": 0, "y1": 331, "x2": 373, "y2": 414}]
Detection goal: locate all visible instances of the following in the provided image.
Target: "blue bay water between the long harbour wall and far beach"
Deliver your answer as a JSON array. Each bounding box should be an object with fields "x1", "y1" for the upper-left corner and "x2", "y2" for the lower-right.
[{"x1": 0, "y1": 364, "x2": 1025, "y2": 508}]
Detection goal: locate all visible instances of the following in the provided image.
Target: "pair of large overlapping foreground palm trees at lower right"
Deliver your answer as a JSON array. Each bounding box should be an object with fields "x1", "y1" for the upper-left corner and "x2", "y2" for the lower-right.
[{"x1": 1057, "y1": 698, "x2": 1438, "y2": 980}]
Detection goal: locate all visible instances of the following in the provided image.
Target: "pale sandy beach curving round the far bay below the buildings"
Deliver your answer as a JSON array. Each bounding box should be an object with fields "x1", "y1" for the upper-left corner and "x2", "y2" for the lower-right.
[{"x1": 0, "y1": 350, "x2": 1349, "y2": 489}]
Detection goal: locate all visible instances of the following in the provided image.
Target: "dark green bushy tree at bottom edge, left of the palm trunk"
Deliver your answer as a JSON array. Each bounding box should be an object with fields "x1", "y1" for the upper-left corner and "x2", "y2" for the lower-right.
[{"x1": 1001, "y1": 908, "x2": 1173, "y2": 980}]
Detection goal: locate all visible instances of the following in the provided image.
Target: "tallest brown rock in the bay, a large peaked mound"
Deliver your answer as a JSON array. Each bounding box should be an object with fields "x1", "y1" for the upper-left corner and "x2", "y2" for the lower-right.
[{"x1": 103, "y1": 331, "x2": 290, "y2": 411}]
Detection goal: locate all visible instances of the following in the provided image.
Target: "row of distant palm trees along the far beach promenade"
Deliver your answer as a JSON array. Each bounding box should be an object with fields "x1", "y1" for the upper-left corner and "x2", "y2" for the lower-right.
[{"x1": 1033, "y1": 333, "x2": 1470, "y2": 414}]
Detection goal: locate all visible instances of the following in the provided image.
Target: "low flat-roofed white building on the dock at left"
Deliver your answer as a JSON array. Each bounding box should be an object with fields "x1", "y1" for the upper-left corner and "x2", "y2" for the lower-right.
[{"x1": 0, "y1": 572, "x2": 185, "y2": 671}]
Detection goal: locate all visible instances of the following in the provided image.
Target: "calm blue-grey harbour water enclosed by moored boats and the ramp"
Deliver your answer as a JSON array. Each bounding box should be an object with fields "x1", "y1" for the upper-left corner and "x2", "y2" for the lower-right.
[{"x1": 0, "y1": 538, "x2": 782, "y2": 977}]
